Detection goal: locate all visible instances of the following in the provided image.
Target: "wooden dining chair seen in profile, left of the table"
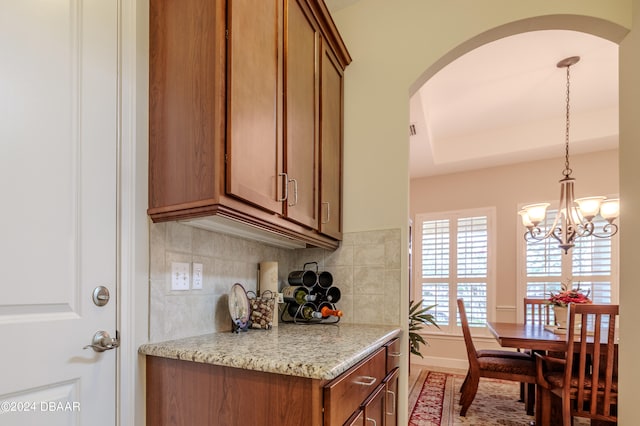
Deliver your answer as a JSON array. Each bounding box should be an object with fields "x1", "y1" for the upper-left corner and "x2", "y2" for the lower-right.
[{"x1": 458, "y1": 299, "x2": 536, "y2": 416}]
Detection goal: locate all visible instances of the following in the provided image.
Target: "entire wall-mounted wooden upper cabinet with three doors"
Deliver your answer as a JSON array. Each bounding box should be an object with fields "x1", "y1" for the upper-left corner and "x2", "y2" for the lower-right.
[{"x1": 148, "y1": 0, "x2": 351, "y2": 249}]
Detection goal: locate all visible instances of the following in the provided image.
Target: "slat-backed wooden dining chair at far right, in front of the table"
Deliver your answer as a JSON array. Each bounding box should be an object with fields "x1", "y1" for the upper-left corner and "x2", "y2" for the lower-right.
[{"x1": 536, "y1": 303, "x2": 619, "y2": 426}]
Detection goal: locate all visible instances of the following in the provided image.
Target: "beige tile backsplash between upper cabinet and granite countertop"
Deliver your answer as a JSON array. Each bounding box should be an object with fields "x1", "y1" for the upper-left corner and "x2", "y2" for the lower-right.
[{"x1": 149, "y1": 222, "x2": 401, "y2": 341}]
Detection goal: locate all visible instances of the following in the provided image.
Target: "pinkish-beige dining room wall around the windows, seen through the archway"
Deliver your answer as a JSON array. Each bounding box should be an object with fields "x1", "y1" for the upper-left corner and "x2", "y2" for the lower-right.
[{"x1": 409, "y1": 150, "x2": 619, "y2": 368}]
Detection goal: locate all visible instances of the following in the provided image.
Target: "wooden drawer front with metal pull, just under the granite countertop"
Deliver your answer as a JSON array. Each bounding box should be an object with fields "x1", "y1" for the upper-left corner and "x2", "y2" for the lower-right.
[{"x1": 324, "y1": 347, "x2": 387, "y2": 426}]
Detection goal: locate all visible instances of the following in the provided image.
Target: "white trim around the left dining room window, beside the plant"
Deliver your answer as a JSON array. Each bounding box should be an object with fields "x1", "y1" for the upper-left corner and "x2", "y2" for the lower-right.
[{"x1": 411, "y1": 207, "x2": 497, "y2": 336}]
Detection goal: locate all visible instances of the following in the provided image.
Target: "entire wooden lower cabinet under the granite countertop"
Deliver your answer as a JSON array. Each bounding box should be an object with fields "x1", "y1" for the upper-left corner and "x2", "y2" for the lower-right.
[{"x1": 146, "y1": 338, "x2": 399, "y2": 426}]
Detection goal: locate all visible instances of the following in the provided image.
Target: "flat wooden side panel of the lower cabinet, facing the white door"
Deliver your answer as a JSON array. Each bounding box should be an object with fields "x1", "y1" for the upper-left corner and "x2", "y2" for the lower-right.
[{"x1": 146, "y1": 356, "x2": 326, "y2": 426}]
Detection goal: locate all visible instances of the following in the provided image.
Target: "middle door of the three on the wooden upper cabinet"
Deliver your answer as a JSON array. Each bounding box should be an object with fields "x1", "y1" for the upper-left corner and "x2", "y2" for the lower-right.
[{"x1": 284, "y1": 0, "x2": 320, "y2": 229}]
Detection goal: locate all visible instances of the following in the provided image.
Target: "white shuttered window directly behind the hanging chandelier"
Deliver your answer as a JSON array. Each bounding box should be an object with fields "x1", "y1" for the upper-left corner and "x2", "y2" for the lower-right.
[{"x1": 521, "y1": 210, "x2": 618, "y2": 314}]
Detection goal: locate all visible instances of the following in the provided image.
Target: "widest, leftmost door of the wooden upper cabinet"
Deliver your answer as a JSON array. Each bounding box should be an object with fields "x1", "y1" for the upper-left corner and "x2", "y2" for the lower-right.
[{"x1": 226, "y1": 0, "x2": 283, "y2": 213}]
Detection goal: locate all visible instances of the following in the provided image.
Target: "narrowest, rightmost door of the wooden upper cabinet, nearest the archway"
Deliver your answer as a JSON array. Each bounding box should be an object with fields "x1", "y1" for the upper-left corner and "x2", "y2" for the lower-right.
[{"x1": 319, "y1": 45, "x2": 343, "y2": 239}]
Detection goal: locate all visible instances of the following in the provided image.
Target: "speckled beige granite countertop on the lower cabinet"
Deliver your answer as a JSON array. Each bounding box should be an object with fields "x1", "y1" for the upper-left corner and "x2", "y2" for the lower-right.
[{"x1": 138, "y1": 323, "x2": 400, "y2": 380}]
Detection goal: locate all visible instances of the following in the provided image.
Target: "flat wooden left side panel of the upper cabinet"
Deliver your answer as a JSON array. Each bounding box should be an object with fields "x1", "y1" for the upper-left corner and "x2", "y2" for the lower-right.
[{"x1": 149, "y1": 0, "x2": 226, "y2": 218}]
